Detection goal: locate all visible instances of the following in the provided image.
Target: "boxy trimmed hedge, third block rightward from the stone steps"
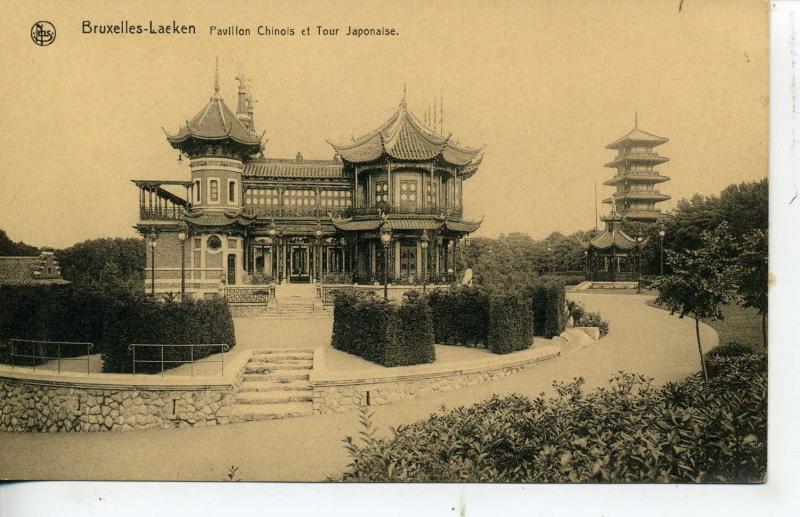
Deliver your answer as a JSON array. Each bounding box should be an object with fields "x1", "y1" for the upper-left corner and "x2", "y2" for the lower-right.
[{"x1": 486, "y1": 291, "x2": 533, "y2": 354}]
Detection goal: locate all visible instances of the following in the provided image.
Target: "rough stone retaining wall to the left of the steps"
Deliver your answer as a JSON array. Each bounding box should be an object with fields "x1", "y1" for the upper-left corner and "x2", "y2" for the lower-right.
[{"x1": 0, "y1": 353, "x2": 250, "y2": 432}]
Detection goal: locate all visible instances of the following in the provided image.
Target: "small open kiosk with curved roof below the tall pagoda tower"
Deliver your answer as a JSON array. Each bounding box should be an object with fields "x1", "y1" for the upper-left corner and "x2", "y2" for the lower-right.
[{"x1": 581, "y1": 199, "x2": 645, "y2": 282}]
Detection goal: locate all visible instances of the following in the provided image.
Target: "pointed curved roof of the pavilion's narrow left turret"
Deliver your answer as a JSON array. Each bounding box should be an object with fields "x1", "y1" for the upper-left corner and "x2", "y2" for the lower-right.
[{"x1": 167, "y1": 95, "x2": 261, "y2": 147}]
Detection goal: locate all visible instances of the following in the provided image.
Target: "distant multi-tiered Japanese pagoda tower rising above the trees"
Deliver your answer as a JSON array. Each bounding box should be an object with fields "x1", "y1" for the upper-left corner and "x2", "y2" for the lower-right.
[{"x1": 603, "y1": 116, "x2": 670, "y2": 222}]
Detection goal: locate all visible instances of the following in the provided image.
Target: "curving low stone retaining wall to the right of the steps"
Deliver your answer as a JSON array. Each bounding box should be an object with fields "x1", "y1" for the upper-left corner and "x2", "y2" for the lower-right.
[{"x1": 311, "y1": 346, "x2": 561, "y2": 414}]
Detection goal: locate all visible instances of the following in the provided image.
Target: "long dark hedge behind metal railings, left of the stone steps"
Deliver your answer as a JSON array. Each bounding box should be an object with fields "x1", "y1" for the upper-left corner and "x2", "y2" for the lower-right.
[{"x1": 0, "y1": 284, "x2": 236, "y2": 373}]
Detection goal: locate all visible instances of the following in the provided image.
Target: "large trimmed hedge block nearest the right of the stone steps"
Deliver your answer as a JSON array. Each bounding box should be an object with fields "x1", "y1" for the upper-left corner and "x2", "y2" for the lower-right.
[{"x1": 331, "y1": 291, "x2": 436, "y2": 366}]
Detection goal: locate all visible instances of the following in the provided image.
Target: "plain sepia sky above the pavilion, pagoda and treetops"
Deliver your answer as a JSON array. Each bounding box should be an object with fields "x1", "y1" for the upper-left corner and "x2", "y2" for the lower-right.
[{"x1": 0, "y1": 0, "x2": 769, "y2": 247}]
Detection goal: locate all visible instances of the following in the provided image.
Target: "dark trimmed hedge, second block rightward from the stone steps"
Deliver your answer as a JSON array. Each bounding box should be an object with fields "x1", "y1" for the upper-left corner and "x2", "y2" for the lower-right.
[{"x1": 428, "y1": 286, "x2": 489, "y2": 346}]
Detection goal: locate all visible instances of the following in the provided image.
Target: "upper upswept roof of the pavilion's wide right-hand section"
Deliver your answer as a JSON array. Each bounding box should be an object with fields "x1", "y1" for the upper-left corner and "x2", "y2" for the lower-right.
[{"x1": 328, "y1": 93, "x2": 481, "y2": 164}]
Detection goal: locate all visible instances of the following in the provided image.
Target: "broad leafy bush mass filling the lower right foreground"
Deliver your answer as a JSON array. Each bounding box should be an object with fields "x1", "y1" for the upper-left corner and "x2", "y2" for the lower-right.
[{"x1": 342, "y1": 354, "x2": 767, "y2": 483}]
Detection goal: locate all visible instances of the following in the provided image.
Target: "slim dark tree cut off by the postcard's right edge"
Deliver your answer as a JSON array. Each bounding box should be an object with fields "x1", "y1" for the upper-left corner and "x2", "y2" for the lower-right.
[{"x1": 739, "y1": 229, "x2": 769, "y2": 350}]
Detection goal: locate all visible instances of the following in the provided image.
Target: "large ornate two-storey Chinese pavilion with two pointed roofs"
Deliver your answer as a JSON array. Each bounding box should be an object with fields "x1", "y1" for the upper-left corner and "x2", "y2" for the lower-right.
[{"x1": 133, "y1": 65, "x2": 481, "y2": 296}]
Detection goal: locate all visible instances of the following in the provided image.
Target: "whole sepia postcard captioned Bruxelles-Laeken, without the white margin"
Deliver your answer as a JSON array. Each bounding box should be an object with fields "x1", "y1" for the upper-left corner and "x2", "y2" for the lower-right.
[{"x1": 0, "y1": 0, "x2": 789, "y2": 500}]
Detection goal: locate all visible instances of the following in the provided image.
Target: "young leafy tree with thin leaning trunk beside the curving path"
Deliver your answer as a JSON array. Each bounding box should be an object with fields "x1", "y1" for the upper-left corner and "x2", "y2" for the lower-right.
[{"x1": 653, "y1": 222, "x2": 743, "y2": 381}]
